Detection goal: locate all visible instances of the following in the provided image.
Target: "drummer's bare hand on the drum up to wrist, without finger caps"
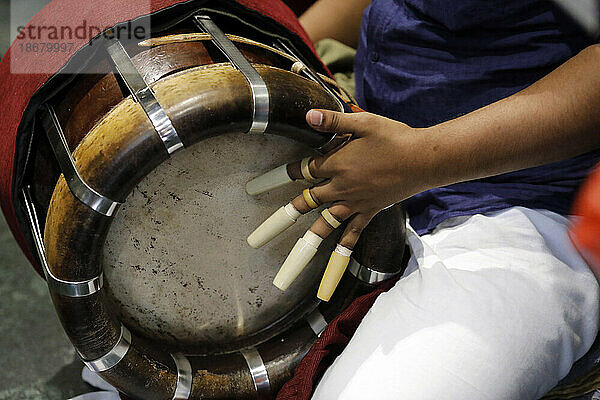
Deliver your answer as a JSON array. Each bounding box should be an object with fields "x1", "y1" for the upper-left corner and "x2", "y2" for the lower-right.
[{"x1": 292, "y1": 110, "x2": 439, "y2": 249}]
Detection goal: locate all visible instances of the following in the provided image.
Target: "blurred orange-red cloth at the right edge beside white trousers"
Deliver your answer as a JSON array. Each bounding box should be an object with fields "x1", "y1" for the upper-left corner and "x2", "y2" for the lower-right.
[{"x1": 569, "y1": 164, "x2": 600, "y2": 279}]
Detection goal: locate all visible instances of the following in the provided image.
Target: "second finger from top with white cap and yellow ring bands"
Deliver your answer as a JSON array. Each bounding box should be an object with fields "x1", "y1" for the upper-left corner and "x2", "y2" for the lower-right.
[{"x1": 246, "y1": 184, "x2": 333, "y2": 249}]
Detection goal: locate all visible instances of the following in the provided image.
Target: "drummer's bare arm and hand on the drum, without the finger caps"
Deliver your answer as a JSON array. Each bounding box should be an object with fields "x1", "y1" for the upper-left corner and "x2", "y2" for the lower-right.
[{"x1": 284, "y1": 45, "x2": 600, "y2": 248}]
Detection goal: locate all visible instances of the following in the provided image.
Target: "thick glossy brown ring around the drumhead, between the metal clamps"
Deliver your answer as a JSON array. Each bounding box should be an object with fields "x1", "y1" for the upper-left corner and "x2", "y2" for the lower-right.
[{"x1": 44, "y1": 57, "x2": 376, "y2": 399}]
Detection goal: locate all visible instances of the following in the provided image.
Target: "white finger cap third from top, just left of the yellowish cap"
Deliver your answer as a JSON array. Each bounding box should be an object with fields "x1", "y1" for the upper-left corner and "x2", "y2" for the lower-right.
[{"x1": 273, "y1": 231, "x2": 323, "y2": 290}]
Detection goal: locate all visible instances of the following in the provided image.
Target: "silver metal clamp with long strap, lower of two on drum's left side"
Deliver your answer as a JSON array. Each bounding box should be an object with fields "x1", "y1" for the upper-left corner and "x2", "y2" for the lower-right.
[{"x1": 22, "y1": 187, "x2": 104, "y2": 297}]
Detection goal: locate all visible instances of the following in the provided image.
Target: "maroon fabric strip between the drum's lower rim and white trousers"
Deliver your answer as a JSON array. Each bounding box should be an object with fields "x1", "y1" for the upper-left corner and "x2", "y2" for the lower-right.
[{"x1": 277, "y1": 276, "x2": 400, "y2": 400}]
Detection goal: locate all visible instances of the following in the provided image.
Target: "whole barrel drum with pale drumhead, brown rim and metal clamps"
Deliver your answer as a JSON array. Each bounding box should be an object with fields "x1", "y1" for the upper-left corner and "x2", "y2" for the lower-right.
[{"x1": 11, "y1": 3, "x2": 404, "y2": 400}]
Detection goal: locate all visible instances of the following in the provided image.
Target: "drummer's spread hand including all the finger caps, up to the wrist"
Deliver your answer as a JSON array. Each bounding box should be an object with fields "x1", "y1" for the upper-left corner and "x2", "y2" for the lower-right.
[{"x1": 246, "y1": 110, "x2": 443, "y2": 300}]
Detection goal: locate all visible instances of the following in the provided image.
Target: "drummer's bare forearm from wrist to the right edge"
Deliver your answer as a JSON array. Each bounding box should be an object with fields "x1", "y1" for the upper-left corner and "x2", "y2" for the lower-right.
[{"x1": 422, "y1": 46, "x2": 600, "y2": 186}]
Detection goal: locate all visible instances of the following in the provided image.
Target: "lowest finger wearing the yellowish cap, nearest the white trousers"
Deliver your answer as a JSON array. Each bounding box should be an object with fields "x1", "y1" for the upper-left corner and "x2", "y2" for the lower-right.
[{"x1": 317, "y1": 214, "x2": 373, "y2": 301}]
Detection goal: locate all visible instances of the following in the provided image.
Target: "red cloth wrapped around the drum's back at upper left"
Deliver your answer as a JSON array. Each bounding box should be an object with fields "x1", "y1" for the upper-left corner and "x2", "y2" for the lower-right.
[{"x1": 0, "y1": 0, "x2": 322, "y2": 271}]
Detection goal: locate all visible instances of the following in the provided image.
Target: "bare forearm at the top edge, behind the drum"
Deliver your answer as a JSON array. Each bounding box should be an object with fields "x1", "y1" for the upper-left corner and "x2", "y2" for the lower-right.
[{"x1": 300, "y1": 0, "x2": 371, "y2": 47}]
